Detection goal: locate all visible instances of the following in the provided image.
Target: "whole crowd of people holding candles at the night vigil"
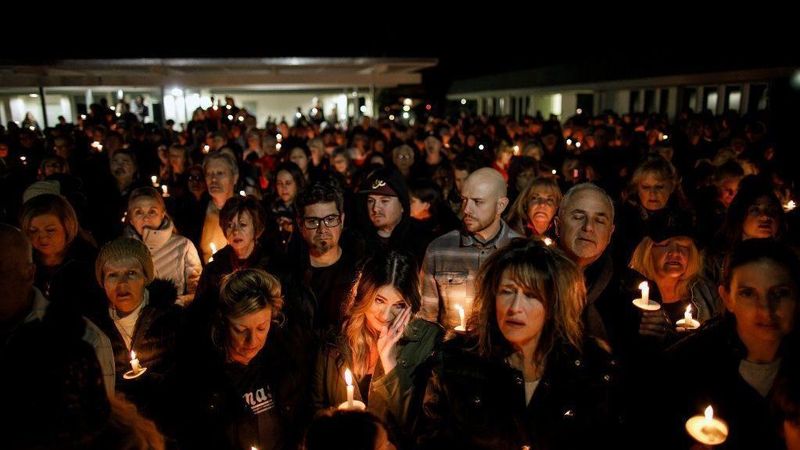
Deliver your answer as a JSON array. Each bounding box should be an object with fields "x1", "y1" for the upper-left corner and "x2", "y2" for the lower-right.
[{"x1": 0, "y1": 97, "x2": 800, "y2": 450}]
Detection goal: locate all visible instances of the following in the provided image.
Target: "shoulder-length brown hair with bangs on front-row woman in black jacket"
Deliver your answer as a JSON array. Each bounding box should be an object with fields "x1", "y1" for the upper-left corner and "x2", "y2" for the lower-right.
[{"x1": 469, "y1": 238, "x2": 586, "y2": 363}]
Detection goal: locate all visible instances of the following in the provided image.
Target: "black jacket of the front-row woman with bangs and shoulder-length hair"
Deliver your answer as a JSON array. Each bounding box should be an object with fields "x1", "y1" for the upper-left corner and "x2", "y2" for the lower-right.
[{"x1": 418, "y1": 338, "x2": 625, "y2": 450}]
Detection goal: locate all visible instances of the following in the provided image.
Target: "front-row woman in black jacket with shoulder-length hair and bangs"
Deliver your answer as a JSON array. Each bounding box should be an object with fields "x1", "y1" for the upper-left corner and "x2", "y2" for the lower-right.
[{"x1": 418, "y1": 239, "x2": 625, "y2": 449}]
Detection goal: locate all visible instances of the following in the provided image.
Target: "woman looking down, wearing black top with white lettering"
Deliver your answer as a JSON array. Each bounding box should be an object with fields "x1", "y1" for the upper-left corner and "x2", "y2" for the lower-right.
[{"x1": 179, "y1": 269, "x2": 313, "y2": 450}]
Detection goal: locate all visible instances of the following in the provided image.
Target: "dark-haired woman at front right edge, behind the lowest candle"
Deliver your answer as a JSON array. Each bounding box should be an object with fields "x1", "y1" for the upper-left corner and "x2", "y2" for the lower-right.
[{"x1": 656, "y1": 239, "x2": 800, "y2": 449}]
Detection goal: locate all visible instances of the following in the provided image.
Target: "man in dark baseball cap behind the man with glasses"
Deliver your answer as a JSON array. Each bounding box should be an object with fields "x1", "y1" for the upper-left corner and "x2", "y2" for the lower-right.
[{"x1": 359, "y1": 168, "x2": 432, "y2": 264}]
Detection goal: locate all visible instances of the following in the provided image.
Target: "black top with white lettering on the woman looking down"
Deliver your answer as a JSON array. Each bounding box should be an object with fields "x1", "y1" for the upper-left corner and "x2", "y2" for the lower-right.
[{"x1": 178, "y1": 325, "x2": 313, "y2": 450}]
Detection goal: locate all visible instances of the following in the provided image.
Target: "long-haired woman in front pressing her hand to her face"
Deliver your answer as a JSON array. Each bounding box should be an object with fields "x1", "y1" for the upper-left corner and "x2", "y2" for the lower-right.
[{"x1": 312, "y1": 251, "x2": 444, "y2": 448}]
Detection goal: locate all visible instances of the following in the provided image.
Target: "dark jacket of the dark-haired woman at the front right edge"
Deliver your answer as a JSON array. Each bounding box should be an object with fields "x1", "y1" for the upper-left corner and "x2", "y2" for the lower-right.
[{"x1": 645, "y1": 314, "x2": 797, "y2": 449}]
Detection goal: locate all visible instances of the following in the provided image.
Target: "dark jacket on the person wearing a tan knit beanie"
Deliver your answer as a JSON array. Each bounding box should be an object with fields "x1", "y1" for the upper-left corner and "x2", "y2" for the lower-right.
[{"x1": 90, "y1": 279, "x2": 182, "y2": 433}]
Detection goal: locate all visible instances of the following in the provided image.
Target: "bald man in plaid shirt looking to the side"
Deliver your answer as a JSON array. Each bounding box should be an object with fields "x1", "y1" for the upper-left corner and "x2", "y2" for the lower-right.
[{"x1": 419, "y1": 168, "x2": 522, "y2": 331}]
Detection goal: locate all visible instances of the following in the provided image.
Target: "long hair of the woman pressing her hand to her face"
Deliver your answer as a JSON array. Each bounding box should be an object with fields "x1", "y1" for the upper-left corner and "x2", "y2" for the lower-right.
[{"x1": 342, "y1": 251, "x2": 422, "y2": 378}]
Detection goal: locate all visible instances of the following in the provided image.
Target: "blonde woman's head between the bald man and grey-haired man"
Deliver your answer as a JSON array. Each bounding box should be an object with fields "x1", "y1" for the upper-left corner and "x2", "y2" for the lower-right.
[{"x1": 506, "y1": 178, "x2": 562, "y2": 239}]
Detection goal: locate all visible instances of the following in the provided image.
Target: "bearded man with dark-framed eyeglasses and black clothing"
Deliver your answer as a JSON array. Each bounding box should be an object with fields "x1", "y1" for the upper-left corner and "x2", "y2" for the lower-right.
[{"x1": 281, "y1": 182, "x2": 363, "y2": 331}]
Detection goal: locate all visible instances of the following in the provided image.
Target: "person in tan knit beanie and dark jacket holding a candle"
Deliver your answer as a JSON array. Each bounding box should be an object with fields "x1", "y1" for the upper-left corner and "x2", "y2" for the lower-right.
[{"x1": 91, "y1": 238, "x2": 181, "y2": 433}]
